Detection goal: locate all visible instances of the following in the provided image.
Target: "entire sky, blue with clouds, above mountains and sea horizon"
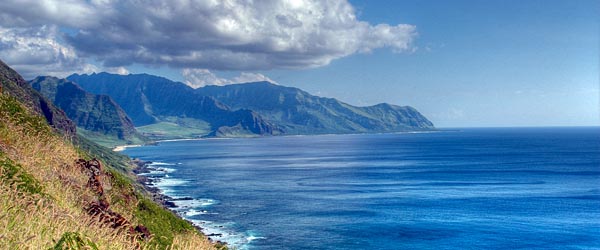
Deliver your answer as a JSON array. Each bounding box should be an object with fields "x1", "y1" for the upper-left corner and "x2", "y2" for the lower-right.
[{"x1": 0, "y1": 0, "x2": 600, "y2": 127}]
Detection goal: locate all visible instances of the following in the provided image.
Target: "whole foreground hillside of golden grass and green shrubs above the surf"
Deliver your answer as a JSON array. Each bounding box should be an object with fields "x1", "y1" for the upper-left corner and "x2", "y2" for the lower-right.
[{"x1": 0, "y1": 91, "x2": 220, "y2": 246}]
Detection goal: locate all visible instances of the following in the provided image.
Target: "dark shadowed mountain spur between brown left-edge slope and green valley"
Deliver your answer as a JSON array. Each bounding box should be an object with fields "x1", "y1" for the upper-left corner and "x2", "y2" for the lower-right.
[{"x1": 30, "y1": 76, "x2": 146, "y2": 144}]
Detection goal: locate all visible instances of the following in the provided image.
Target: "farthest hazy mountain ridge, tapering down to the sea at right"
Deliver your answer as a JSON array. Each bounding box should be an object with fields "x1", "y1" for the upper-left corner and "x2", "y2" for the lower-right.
[{"x1": 196, "y1": 82, "x2": 434, "y2": 134}]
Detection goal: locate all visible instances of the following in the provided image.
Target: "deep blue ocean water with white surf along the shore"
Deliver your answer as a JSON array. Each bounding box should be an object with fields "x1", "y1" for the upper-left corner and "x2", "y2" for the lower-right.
[{"x1": 125, "y1": 127, "x2": 600, "y2": 249}]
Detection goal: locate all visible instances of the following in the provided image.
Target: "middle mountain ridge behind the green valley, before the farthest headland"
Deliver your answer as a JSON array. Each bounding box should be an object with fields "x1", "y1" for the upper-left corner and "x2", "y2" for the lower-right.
[{"x1": 67, "y1": 73, "x2": 281, "y2": 139}]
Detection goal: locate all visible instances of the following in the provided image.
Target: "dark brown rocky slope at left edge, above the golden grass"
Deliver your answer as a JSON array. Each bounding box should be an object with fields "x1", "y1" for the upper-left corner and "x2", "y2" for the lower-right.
[{"x1": 0, "y1": 60, "x2": 76, "y2": 139}]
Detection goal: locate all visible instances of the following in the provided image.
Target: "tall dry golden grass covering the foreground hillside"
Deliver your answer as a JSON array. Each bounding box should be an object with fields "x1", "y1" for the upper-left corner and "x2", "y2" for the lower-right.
[{"x1": 0, "y1": 93, "x2": 214, "y2": 249}]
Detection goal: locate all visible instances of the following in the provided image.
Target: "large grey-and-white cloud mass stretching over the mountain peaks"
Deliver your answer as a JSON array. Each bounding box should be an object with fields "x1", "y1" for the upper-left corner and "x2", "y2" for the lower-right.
[{"x1": 0, "y1": 0, "x2": 416, "y2": 71}]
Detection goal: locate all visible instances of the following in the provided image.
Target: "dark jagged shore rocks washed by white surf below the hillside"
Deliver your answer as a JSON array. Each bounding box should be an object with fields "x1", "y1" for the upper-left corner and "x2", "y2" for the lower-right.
[{"x1": 132, "y1": 159, "x2": 227, "y2": 243}]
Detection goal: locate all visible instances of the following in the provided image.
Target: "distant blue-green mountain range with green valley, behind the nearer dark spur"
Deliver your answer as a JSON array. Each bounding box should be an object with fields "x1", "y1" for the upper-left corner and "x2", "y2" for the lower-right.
[{"x1": 67, "y1": 73, "x2": 434, "y2": 139}]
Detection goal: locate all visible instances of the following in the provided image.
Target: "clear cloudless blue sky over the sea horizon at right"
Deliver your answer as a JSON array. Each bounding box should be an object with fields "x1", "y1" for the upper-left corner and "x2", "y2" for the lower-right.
[{"x1": 276, "y1": 1, "x2": 600, "y2": 127}]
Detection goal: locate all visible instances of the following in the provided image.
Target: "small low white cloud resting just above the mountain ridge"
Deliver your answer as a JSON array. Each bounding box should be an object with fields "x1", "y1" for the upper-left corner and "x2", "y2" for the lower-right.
[{"x1": 181, "y1": 68, "x2": 277, "y2": 88}]
